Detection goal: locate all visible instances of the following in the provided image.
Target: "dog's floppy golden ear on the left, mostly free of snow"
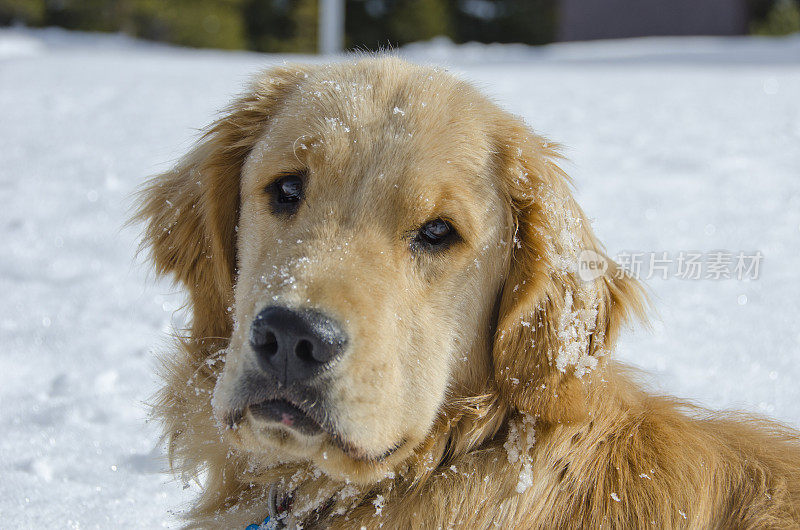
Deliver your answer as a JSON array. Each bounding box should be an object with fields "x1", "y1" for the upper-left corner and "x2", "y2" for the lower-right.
[{"x1": 133, "y1": 66, "x2": 308, "y2": 338}]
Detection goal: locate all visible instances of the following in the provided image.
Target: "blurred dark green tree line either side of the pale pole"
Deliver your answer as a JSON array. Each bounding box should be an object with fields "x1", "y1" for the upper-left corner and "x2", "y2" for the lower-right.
[{"x1": 0, "y1": 0, "x2": 564, "y2": 53}]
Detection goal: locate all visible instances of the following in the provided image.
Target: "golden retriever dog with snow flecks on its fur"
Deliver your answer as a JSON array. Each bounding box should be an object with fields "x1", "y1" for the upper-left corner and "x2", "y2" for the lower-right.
[{"x1": 138, "y1": 57, "x2": 800, "y2": 529}]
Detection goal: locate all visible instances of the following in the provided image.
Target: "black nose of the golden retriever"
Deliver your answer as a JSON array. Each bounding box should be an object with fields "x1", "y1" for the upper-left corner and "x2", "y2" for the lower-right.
[{"x1": 250, "y1": 306, "x2": 347, "y2": 384}]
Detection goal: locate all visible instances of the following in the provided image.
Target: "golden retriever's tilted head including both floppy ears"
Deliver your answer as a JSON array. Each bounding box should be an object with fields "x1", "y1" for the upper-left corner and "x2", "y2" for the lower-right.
[{"x1": 140, "y1": 58, "x2": 640, "y2": 480}]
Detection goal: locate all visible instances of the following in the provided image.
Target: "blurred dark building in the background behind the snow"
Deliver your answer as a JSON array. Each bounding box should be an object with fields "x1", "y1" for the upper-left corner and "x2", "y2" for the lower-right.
[{"x1": 557, "y1": 0, "x2": 748, "y2": 41}]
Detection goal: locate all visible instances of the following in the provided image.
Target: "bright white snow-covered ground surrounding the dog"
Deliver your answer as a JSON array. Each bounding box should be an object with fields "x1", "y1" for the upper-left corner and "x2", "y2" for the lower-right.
[{"x1": 0, "y1": 29, "x2": 800, "y2": 528}]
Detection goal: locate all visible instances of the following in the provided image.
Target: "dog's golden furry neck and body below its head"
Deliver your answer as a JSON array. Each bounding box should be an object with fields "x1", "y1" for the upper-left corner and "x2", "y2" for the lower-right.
[{"x1": 155, "y1": 341, "x2": 800, "y2": 528}]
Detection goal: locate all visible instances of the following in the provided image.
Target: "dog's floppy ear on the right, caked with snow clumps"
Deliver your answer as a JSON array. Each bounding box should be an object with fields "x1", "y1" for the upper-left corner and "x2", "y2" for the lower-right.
[{"x1": 493, "y1": 116, "x2": 646, "y2": 423}]
